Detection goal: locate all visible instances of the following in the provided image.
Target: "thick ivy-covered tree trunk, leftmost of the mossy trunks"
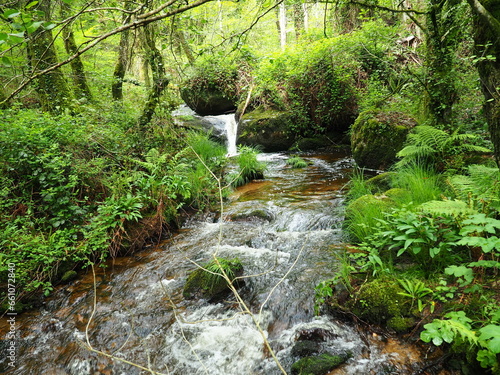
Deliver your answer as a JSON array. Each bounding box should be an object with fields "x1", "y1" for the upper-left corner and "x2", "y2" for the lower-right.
[{"x1": 27, "y1": 0, "x2": 70, "y2": 113}]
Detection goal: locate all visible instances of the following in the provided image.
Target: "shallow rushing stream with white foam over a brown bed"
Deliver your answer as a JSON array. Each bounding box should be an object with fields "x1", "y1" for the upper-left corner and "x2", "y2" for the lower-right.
[{"x1": 0, "y1": 114, "x2": 434, "y2": 375}]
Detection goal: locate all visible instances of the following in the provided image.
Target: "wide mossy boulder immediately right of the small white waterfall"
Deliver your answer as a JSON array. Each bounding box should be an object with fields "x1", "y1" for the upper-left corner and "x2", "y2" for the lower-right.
[{"x1": 238, "y1": 108, "x2": 295, "y2": 152}]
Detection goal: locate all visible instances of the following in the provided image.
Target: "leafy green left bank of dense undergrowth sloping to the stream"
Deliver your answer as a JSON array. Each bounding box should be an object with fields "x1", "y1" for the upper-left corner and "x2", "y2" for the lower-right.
[{"x1": 0, "y1": 108, "x2": 263, "y2": 311}]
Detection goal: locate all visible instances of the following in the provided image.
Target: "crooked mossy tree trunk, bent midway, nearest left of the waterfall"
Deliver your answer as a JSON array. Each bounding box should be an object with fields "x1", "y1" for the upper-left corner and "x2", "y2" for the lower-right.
[{"x1": 138, "y1": 24, "x2": 169, "y2": 128}]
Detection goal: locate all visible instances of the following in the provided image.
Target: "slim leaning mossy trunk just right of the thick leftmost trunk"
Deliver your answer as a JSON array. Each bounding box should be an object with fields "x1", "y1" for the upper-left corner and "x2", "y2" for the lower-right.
[{"x1": 61, "y1": 2, "x2": 92, "y2": 101}]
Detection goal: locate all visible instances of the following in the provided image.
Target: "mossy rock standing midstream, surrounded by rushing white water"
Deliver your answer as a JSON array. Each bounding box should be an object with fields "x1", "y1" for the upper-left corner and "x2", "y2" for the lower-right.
[{"x1": 183, "y1": 258, "x2": 243, "y2": 300}]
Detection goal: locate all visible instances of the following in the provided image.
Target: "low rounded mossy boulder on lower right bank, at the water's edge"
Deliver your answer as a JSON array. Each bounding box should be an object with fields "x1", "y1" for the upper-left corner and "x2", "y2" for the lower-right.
[{"x1": 347, "y1": 279, "x2": 411, "y2": 324}]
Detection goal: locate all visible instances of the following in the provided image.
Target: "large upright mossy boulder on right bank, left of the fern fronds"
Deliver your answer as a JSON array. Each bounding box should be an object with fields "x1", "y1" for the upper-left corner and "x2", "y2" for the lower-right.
[{"x1": 351, "y1": 110, "x2": 417, "y2": 169}]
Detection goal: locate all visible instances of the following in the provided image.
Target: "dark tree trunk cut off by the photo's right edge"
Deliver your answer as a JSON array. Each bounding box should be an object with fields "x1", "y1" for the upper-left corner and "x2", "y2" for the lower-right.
[{"x1": 467, "y1": 0, "x2": 500, "y2": 166}]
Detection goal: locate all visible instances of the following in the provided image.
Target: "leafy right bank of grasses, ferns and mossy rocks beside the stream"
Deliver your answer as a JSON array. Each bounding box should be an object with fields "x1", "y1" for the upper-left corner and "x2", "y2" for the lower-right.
[{"x1": 316, "y1": 159, "x2": 500, "y2": 374}]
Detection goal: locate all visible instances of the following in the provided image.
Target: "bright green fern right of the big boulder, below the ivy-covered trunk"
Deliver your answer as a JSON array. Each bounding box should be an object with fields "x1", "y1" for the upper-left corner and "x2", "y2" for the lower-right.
[{"x1": 397, "y1": 125, "x2": 491, "y2": 166}]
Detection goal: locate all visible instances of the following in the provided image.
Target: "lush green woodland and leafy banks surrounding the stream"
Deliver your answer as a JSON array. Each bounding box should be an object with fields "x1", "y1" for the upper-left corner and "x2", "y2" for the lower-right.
[{"x1": 0, "y1": 0, "x2": 500, "y2": 374}]
